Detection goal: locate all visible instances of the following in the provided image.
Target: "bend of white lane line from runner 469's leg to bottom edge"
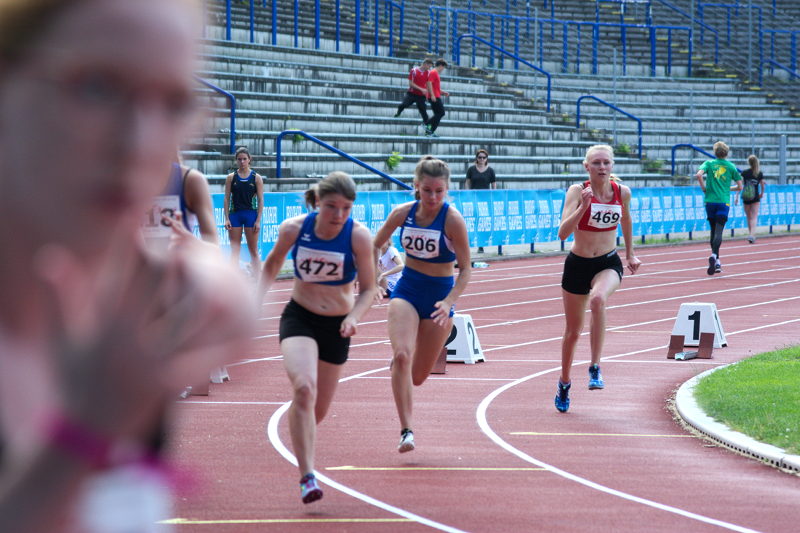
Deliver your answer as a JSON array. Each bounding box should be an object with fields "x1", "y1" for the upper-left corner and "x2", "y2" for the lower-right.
[{"x1": 476, "y1": 362, "x2": 758, "y2": 533}]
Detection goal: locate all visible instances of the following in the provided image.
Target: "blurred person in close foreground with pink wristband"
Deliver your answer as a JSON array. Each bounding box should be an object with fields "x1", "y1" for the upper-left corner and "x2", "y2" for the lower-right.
[{"x1": 0, "y1": 0, "x2": 254, "y2": 533}]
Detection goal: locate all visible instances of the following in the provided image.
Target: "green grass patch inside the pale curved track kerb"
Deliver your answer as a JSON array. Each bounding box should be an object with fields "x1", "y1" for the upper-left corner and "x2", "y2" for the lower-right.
[{"x1": 694, "y1": 346, "x2": 800, "y2": 455}]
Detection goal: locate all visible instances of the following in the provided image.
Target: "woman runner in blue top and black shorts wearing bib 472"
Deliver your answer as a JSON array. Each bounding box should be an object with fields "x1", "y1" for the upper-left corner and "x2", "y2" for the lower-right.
[{"x1": 260, "y1": 172, "x2": 377, "y2": 503}]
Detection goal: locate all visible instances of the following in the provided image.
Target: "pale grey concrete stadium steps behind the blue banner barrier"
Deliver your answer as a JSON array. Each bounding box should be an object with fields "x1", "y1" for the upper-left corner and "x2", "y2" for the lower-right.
[{"x1": 187, "y1": 0, "x2": 800, "y2": 187}]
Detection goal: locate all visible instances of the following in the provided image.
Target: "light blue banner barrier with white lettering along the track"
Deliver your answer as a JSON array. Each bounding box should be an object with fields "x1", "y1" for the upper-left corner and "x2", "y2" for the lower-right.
[{"x1": 212, "y1": 184, "x2": 800, "y2": 262}]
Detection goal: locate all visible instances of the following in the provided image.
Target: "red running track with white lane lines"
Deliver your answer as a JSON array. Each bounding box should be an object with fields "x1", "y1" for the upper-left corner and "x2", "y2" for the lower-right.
[{"x1": 173, "y1": 236, "x2": 800, "y2": 533}]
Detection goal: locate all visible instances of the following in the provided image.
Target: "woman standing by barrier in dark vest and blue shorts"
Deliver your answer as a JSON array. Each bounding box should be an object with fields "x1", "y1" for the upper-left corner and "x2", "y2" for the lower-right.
[{"x1": 225, "y1": 146, "x2": 264, "y2": 276}]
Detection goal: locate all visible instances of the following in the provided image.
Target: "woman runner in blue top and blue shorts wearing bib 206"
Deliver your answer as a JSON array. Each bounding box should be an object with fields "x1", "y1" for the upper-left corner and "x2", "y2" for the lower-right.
[{"x1": 374, "y1": 156, "x2": 471, "y2": 453}]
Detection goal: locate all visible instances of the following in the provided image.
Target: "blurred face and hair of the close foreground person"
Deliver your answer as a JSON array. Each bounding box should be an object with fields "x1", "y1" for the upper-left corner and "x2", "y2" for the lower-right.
[{"x1": 0, "y1": 0, "x2": 199, "y2": 246}]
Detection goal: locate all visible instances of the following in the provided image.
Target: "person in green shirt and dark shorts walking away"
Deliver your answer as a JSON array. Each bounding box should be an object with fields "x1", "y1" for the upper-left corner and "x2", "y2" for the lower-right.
[{"x1": 695, "y1": 141, "x2": 742, "y2": 276}]
